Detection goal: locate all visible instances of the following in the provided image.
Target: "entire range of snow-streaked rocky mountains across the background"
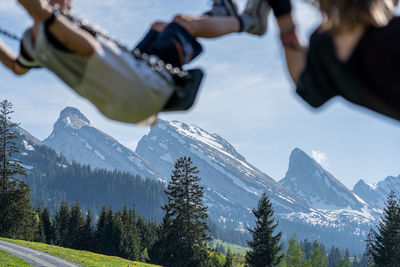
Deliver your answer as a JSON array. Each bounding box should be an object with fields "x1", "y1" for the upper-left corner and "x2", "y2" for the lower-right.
[{"x1": 14, "y1": 107, "x2": 400, "y2": 252}]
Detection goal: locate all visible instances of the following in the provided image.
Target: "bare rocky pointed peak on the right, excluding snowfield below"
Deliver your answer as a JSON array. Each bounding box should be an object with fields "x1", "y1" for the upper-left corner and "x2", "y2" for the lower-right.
[{"x1": 279, "y1": 148, "x2": 366, "y2": 210}]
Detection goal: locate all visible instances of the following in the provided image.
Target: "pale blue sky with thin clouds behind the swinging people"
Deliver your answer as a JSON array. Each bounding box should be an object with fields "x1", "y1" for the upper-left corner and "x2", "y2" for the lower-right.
[{"x1": 0, "y1": 0, "x2": 400, "y2": 189}]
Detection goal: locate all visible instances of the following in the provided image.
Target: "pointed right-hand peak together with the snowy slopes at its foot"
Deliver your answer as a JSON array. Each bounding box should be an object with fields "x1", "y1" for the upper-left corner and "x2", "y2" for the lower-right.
[{"x1": 279, "y1": 148, "x2": 381, "y2": 247}]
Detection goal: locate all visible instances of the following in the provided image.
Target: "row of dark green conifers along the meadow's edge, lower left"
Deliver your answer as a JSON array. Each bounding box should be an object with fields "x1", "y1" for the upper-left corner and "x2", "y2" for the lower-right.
[{"x1": 34, "y1": 201, "x2": 157, "y2": 262}]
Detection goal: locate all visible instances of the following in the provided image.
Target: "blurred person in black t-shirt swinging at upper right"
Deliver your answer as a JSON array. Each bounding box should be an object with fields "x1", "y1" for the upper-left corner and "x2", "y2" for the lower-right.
[{"x1": 268, "y1": 0, "x2": 400, "y2": 120}]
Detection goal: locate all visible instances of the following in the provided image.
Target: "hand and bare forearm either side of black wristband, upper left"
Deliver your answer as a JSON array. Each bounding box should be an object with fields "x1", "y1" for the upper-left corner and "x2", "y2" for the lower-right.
[{"x1": 18, "y1": 0, "x2": 99, "y2": 56}]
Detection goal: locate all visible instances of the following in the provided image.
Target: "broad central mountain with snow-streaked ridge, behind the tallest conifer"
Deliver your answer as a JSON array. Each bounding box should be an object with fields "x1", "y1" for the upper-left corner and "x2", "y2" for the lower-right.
[{"x1": 136, "y1": 121, "x2": 309, "y2": 228}]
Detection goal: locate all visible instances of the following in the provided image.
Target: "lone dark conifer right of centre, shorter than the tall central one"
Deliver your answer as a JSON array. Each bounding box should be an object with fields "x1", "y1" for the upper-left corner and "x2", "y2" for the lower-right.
[{"x1": 246, "y1": 193, "x2": 283, "y2": 267}]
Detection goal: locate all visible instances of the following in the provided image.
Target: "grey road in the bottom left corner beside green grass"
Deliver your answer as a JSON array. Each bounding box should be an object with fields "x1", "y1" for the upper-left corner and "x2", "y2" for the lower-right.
[{"x1": 0, "y1": 241, "x2": 81, "y2": 267}]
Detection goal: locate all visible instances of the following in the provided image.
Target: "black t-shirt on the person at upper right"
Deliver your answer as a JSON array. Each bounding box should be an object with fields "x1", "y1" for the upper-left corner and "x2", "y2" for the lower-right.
[{"x1": 297, "y1": 17, "x2": 400, "y2": 120}]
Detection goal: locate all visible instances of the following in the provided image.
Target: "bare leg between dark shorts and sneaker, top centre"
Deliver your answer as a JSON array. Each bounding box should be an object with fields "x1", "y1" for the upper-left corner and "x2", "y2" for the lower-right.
[{"x1": 173, "y1": 15, "x2": 240, "y2": 38}]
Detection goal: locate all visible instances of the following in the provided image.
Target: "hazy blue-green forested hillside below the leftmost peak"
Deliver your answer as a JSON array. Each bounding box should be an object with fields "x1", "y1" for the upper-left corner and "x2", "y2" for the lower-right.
[{"x1": 18, "y1": 138, "x2": 166, "y2": 221}]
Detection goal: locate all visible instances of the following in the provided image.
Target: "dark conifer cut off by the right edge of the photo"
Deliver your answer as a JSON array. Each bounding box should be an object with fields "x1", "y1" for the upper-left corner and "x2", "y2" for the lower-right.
[{"x1": 367, "y1": 191, "x2": 400, "y2": 266}]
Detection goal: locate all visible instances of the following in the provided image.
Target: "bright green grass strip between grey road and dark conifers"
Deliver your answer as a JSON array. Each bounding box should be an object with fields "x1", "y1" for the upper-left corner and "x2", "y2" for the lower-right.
[{"x1": 0, "y1": 238, "x2": 159, "y2": 267}]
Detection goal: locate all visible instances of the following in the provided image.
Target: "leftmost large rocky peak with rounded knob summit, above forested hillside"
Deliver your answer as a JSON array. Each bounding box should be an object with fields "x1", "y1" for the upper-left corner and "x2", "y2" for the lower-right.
[{"x1": 43, "y1": 107, "x2": 159, "y2": 181}]
